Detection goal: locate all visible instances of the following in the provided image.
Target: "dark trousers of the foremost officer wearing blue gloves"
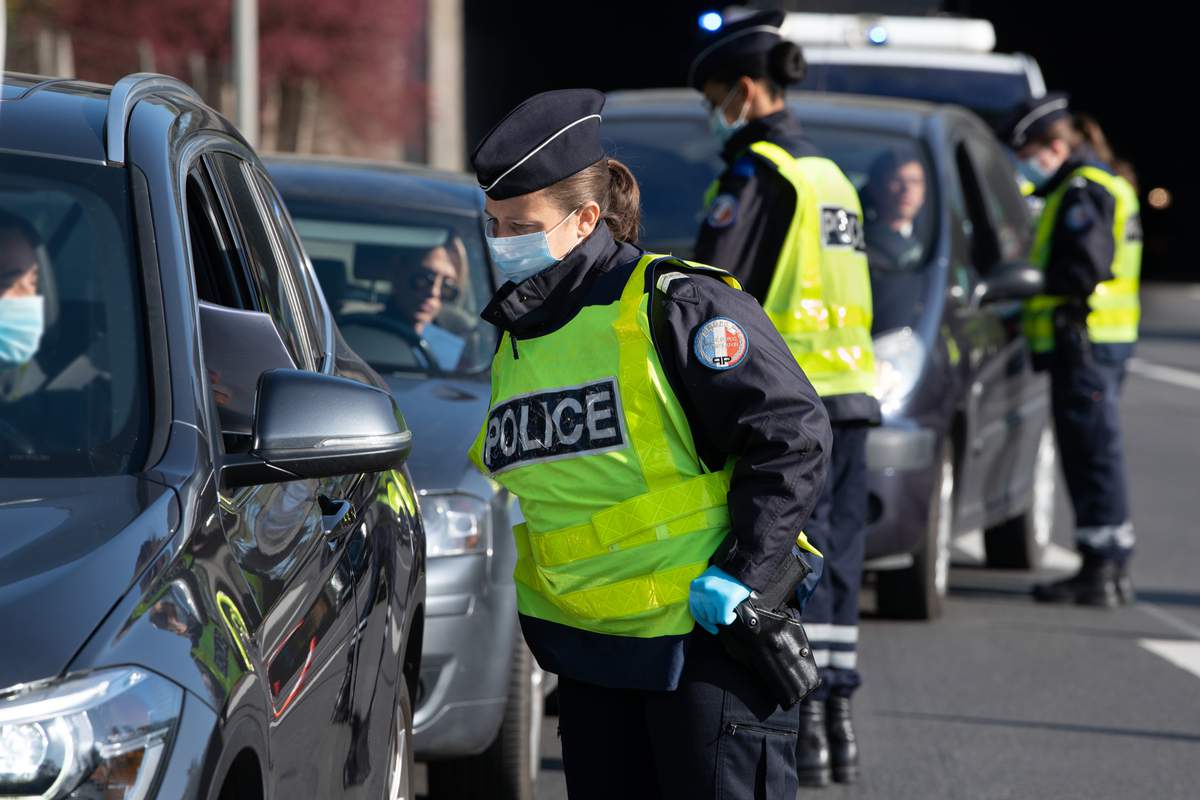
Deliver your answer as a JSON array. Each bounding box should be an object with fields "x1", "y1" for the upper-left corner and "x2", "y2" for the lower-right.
[{"x1": 558, "y1": 627, "x2": 799, "y2": 800}]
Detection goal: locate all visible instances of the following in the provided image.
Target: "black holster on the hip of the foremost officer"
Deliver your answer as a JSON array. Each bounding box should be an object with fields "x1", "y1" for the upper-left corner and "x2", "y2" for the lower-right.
[{"x1": 716, "y1": 547, "x2": 821, "y2": 709}]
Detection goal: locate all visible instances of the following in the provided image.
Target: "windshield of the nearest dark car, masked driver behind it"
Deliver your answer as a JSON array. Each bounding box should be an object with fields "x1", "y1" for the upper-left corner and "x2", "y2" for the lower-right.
[{"x1": 0, "y1": 155, "x2": 150, "y2": 477}]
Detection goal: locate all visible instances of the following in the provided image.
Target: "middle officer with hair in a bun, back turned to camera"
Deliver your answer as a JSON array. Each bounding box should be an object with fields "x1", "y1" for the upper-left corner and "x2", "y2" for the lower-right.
[{"x1": 689, "y1": 12, "x2": 880, "y2": 786}]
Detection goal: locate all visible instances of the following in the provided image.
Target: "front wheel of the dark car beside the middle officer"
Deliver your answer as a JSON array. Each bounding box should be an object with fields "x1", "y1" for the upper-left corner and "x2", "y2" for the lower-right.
[{"x1": 876, "y1": 440, "x2": 954, "y2": 620}]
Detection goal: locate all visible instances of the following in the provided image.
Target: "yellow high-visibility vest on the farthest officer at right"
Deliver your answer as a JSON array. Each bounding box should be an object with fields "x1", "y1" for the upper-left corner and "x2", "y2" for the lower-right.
[{"x1": 1024, "y1": 166, "x2": 1141, "y2": 353}]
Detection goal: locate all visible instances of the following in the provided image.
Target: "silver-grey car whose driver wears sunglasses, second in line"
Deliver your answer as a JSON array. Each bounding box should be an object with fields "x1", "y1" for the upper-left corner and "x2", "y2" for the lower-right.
[{"x1": 268, "y1": 158, "x2": 553, "y2": 799}]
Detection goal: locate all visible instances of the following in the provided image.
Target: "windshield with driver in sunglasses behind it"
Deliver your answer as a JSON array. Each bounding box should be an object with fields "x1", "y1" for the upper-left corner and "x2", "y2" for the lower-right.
[{"x1": 288, "y1": 199, "x2": 496, "y2": 374}]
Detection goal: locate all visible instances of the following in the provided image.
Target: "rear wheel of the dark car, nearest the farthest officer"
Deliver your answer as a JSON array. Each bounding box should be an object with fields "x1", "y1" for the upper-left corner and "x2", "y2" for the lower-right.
[{"x1": 983, "y1": 426, "x2": 1058, "y2": 570}]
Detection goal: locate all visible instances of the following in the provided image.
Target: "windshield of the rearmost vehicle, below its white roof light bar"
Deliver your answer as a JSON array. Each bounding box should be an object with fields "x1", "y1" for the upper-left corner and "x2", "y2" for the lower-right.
[{"x1": 796, "y1": 64, "x2": 1031, "y2": 128}]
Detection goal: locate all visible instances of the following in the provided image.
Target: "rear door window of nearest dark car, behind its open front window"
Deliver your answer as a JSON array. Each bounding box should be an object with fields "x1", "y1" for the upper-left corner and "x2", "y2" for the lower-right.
[{"x1": 212, "y1": 152, "x2": 317, "y2": 369}]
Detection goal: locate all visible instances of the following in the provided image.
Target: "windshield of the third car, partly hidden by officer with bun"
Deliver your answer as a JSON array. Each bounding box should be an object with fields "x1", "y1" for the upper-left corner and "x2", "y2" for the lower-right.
[{"x1": 604, "y1": 114, "x2": 937, "y2": 271}]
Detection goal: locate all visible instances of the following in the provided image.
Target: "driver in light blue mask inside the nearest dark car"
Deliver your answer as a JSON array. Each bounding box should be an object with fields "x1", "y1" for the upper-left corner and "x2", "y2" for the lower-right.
[{"x1": 0, "y1": 212, "x2": 44, "y2": 402}]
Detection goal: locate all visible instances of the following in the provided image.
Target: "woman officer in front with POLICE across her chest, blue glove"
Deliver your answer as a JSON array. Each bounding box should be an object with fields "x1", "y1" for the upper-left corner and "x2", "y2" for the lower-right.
[{"x1": 472, "y1": 90, "x2": 829, "y2": 798}]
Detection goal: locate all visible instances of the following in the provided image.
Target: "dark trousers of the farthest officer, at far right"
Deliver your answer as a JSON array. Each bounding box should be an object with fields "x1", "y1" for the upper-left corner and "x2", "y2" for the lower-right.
[{"x1": 1049, "y1": 323, "x2": 1133, "y2": 561}]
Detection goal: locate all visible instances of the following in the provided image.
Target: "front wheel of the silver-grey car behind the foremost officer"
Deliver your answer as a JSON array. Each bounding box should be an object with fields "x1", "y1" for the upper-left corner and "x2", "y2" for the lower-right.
[{"x1": 428, "y1": 642, "x2": 545, "y2": 800}]
